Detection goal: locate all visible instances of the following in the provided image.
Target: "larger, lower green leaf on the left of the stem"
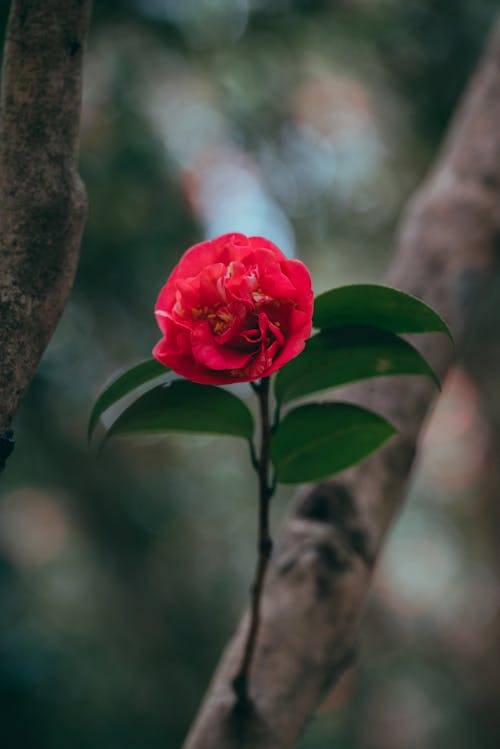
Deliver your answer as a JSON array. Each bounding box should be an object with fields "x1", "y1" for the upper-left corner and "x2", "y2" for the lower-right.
[{"x1": 107, "y1": 380, "x2": 254, "y2": 440}]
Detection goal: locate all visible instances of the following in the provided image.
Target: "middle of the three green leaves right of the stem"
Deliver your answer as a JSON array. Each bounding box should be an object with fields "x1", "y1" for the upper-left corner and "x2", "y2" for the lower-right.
[{"x1": 274, "y1": 326, "x2": 440, "y2": 403}]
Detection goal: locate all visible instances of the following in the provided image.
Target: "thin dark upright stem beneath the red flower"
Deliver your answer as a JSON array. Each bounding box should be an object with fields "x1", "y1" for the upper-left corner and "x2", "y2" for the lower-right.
[{"x1": 233, "y1": 377, "x2": 274, "y2": 706}]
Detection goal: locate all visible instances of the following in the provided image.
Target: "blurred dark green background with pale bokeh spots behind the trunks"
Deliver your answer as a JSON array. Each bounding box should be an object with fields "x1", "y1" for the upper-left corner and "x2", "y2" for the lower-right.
[{"x1": 0, "y1": 0, "x2": 500, "y2": 749}]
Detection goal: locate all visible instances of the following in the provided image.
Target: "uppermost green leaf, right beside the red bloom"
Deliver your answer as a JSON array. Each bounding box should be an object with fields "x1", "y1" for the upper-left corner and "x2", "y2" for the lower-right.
[{"x1": 313, "y1": 284, "x2": 453, "y2": 340}]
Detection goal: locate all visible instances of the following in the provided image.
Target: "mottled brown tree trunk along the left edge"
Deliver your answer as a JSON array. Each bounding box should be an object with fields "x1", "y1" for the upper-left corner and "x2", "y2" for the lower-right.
[{"x1": 0, "y1": 0, "x2": 91, "y2": 444}]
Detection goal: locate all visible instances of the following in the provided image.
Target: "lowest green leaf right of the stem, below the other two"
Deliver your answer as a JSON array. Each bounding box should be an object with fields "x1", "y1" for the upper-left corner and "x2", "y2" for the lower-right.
[{"x1": 271, "y1": 403, "x2": 396, "y2": 484}]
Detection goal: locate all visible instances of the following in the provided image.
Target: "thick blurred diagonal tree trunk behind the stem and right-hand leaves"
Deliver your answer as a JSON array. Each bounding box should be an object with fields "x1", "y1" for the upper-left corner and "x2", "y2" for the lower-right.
[{"x1": 185, "y1": 16, "x2": 500, "y2": 749}]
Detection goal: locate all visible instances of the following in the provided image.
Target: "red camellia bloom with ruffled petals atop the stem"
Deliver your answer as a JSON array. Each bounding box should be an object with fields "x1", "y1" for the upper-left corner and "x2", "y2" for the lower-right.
[{"x1": 153, "y1": 234, "x2": 313, "y2": 385}]
